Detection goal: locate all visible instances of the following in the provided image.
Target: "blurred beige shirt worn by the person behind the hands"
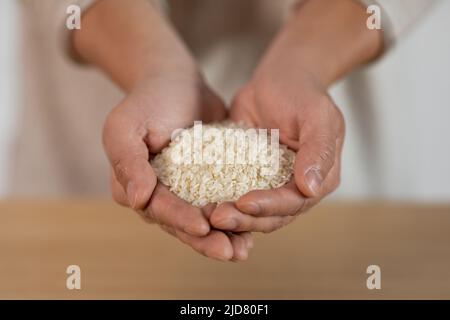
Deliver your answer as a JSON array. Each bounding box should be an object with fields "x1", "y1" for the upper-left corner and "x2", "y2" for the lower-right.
[{"x1": 12, "y1": 0, "x2": 429, "y2": 195}]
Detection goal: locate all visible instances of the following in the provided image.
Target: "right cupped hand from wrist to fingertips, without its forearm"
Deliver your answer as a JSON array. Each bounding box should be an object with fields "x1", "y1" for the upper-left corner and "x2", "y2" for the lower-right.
[{"x1": 211, "y1": 66, "x2": 345, "y2": 232}]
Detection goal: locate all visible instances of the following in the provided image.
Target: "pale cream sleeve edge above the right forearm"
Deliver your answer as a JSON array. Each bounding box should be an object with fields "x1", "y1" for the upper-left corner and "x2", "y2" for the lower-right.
[{"x1": 360, "y1": 0, "x2": 436, "y2": 48}]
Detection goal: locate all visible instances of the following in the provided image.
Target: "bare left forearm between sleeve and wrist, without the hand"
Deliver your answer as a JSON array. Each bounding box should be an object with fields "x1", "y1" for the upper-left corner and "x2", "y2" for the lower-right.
[{"x1": 72, "y1": 0, "x2": 196, "y2": 91}]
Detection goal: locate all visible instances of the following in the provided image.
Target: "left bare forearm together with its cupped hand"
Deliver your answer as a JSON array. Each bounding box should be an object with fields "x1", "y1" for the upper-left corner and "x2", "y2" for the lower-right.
[{"x1": 73, "y1": 0, "x2": 252, "y2": 260}]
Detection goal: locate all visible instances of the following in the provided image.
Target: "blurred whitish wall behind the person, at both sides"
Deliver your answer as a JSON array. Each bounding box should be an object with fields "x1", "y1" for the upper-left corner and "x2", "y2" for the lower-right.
[{"x1": 0, "y1": 0, "x2": 450, "y2": 202}]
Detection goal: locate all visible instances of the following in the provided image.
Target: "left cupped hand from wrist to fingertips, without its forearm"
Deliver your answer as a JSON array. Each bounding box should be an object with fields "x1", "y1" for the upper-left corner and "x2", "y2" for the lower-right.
[{"x1": 103, "y1": 72, "x2": 252, "y2": 260}]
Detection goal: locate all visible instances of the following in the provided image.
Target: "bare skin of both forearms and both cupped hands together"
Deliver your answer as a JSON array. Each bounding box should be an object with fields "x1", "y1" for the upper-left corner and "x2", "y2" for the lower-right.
[{"x1": 73, "y1": 0, "x2": 382, "y2": 261}]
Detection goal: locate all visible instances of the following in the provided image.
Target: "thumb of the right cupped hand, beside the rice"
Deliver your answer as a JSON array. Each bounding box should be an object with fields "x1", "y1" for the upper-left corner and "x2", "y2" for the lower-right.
[{"x1": 294, "y1": 132, "x2": 336, "y2": 197}]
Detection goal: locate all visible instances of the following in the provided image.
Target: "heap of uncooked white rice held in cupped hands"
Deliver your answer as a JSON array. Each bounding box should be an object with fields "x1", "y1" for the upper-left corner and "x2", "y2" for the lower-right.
[{"x1": 151, "y1": 122, "x2": 295, "y2": 207}]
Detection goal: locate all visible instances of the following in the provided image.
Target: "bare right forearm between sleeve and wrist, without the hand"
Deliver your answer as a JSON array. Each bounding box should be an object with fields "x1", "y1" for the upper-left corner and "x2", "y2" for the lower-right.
[{"x1": 256, "y1": 0, "x2": 383, "y2": 86}]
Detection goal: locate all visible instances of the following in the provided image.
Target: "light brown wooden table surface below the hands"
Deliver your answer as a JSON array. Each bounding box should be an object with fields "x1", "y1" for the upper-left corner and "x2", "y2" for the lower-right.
[{"x1": 0, "y1": 200, "x2": 450, "y2": 299}]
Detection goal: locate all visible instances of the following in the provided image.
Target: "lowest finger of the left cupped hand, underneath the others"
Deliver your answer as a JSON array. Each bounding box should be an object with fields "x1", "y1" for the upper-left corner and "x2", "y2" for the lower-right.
[{"x1": 161, "y1": 225, "x2": 233, "y2": 261}]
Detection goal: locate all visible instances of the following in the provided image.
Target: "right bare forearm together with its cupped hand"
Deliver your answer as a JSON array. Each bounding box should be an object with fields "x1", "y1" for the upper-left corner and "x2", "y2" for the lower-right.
[{"x1": 211, "y1": 0, "x2": 382, "y2": 232}]
